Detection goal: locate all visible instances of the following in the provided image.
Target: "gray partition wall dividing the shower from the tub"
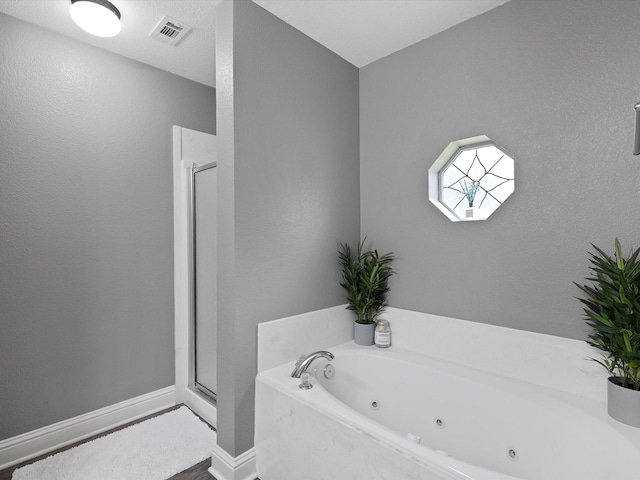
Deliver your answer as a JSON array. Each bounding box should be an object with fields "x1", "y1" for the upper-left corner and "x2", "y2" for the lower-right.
[{"x1": 216, "y1": 0, "x2": 360, "y2": 456}]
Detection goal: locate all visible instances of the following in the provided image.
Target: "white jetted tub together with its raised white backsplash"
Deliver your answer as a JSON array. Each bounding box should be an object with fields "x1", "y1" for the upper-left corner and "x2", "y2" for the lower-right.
[{"x1": 255, "y1": 307, "x2": 640, "y2": 480}]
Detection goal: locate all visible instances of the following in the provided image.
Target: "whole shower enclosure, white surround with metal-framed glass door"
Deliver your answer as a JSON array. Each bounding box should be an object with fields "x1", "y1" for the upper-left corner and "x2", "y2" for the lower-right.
[{"x1": 172, "y1": 125, "x2": 220, "y2": 427}]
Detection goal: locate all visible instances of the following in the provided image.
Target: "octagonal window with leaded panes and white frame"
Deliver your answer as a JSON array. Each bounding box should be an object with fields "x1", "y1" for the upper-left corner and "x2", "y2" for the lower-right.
[{"x1": 429, "y1": 135, "x2": 515, "y2": 222}]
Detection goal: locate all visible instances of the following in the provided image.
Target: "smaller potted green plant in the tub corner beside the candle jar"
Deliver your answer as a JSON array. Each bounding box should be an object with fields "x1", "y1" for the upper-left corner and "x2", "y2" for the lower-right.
[{"x1": 338, "y1": 237, "x2": 394, "y2": 345}]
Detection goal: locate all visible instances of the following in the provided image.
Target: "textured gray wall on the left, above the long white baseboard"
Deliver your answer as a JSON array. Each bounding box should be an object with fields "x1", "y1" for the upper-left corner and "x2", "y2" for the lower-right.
[{"x1": 0, "y1": 14, "x2": 215, "y2": 440}]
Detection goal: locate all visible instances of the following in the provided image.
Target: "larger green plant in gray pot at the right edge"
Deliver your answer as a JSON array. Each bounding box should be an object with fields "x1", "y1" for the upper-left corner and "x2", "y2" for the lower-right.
[{"x1": 574, "y1": 238, "x2": 640, "y2": 427}]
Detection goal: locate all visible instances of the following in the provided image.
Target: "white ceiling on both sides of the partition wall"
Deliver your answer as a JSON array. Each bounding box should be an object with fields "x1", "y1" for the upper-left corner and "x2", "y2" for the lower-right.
[{"x1": 0, "y1": 0, "x2": 508, "y2": 86}]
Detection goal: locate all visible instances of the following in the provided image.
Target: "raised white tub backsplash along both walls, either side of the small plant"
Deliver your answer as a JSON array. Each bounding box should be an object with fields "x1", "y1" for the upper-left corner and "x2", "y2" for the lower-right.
[{"x1": 258, "y1": 305, "x2": 607, "y2": 402}]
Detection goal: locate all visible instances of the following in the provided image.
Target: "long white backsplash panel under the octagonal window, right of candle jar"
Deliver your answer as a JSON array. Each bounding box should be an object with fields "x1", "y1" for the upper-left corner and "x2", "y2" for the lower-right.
[{"x1": 385, "y1": 308, "x2": 608, "y2": 402}]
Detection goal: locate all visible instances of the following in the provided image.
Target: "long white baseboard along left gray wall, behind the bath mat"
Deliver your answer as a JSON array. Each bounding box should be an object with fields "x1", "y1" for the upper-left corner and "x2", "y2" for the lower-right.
[{"x1": 0, "y1": 386, "x2": 176, "y2": 470}]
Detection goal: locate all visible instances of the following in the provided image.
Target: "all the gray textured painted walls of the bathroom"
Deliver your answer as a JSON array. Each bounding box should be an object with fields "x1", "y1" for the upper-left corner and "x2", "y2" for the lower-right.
[{"x1": 8, "y1": 0, "x2": 640, "y2": 455}]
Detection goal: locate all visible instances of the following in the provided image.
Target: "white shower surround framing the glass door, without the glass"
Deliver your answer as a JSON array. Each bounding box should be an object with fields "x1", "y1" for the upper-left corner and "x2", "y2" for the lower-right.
[{"x1": 173, "y1": 125, "x2": 217, "y2": 427}]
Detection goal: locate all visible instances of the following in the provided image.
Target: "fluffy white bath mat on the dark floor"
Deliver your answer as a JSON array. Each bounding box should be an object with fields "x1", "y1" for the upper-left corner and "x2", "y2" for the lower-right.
[{"x1": 12, "y1": 407, "x2": 216, "y2": 480}]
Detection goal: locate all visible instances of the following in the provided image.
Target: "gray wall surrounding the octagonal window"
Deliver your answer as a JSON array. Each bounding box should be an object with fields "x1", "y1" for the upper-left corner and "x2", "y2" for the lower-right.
[{"x1": 360, "y1": 0, "x2": 640, "y2": 339}]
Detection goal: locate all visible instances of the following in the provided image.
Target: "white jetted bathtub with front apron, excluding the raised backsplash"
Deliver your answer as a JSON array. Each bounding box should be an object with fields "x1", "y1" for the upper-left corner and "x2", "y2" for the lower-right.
[{"x1": 255, "y1": 342, "x2": 640, "y2": 480}]
